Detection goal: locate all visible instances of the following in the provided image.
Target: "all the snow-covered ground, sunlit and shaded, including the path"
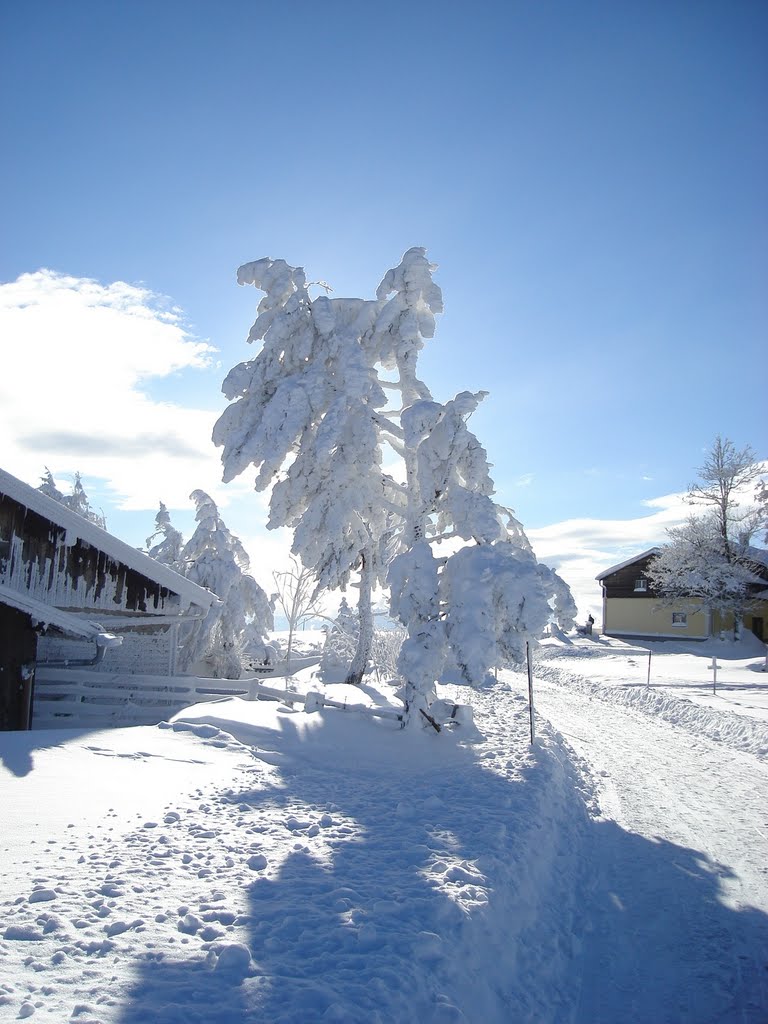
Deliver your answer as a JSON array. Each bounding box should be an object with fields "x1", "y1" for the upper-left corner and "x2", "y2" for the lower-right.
[{"x1": 0, "y1": 639, "x2": 768, "y2": 1024}]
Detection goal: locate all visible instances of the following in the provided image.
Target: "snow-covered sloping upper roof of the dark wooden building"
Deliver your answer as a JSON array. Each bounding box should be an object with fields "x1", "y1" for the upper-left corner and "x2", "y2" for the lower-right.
[{"x1": 0, "y1": 469, "x2": 217, "y2": 608}]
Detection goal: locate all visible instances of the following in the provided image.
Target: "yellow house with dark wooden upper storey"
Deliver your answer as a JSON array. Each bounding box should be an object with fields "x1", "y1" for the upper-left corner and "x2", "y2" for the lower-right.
[{"x1": 596, "y1": 548, "x2": 768, "y2": 640}]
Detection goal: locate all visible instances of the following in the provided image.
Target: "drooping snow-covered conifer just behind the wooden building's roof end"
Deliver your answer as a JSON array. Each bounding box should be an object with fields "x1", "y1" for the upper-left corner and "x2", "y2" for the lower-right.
[{"x1": 181, "y1": 490, "x2": 274, "y2": 679}]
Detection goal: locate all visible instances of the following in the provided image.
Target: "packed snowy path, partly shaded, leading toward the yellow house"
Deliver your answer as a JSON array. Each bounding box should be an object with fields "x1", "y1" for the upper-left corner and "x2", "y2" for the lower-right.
[{"x1": 528, "y1": 667, "x2": 768, "y2": 1024}]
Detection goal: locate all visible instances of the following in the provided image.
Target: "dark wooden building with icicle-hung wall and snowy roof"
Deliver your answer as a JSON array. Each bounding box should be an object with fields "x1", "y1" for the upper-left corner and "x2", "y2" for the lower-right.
[{"x1": 0, "y1": 470, "x2": 217, "y2": 730}]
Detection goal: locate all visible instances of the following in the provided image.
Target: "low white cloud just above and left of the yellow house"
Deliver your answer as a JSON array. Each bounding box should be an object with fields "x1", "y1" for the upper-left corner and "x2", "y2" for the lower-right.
[{"x1": 526, "y1": 494, "x2": 690, "y2": 622}]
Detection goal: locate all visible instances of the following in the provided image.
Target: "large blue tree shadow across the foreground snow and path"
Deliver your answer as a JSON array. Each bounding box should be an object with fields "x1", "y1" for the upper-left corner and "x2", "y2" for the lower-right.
[{"x1": 120, "y1": 708, "x2": 768, "y2": 1024}]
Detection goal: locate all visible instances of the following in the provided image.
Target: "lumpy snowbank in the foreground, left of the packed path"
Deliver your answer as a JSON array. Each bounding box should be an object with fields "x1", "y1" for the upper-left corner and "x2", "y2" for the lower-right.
[{"x1": 0, "y1": 687, "x2": 588, "y2": 1024}]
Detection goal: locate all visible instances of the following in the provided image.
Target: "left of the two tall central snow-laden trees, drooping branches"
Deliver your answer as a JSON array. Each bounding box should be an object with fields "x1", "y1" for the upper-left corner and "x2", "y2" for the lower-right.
[{"x1": 213, "y1": 259, "x2": 385, "y2": 684}]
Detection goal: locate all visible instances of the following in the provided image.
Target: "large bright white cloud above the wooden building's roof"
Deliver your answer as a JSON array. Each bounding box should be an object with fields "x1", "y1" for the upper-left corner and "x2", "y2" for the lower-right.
[{"x1": 0, "y1": 270, "x2": 237, "y2": 509}]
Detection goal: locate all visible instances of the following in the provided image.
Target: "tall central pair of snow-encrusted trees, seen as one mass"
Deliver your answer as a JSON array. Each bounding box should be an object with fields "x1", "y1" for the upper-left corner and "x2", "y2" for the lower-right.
[{"x1": 213, "y1": 248, "x2": 573, "y2": 718}]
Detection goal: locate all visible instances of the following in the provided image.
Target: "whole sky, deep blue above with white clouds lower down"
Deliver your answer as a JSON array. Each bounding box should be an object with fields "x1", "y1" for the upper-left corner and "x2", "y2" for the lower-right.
[{"x1": 0, "y1": 0, "x2": 768, "y2": 610}]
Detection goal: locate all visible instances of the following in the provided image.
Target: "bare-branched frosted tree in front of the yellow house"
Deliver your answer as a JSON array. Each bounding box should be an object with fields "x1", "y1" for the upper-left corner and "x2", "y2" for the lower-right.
[{"x1": 647, "y1": 435, "x2": 765, "y2": 635}]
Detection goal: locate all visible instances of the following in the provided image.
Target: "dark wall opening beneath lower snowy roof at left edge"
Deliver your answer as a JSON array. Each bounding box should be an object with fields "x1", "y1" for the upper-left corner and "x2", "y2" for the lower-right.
[{"x1": 0, "y1": 604, "x2": 37, "y2": 731}]
